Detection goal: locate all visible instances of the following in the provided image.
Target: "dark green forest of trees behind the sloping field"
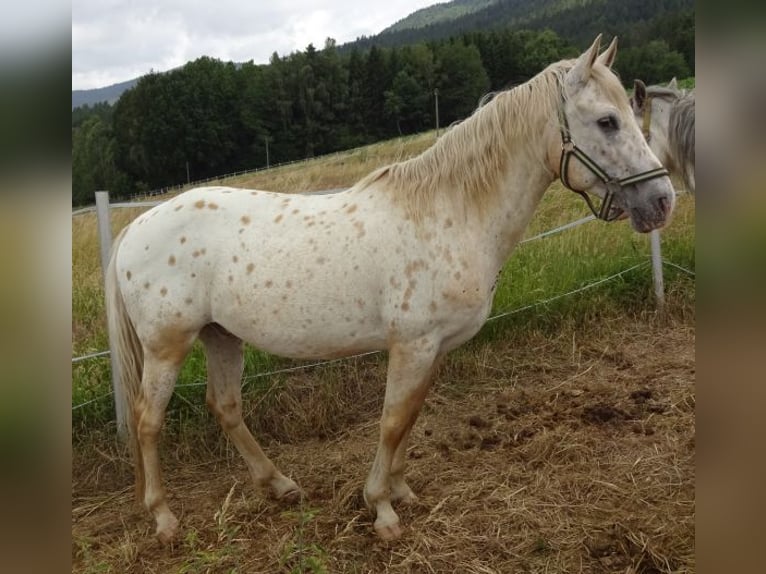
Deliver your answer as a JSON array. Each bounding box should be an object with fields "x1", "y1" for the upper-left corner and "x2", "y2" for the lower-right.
[{"x1": 72, "y1": 10, "x2": 694, "y2": 205}]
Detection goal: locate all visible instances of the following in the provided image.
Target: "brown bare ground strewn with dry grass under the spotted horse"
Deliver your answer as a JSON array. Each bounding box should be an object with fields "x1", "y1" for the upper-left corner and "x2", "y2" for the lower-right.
[{"x1": 72, "y1": 321, "x2": 695, "y2": 574}]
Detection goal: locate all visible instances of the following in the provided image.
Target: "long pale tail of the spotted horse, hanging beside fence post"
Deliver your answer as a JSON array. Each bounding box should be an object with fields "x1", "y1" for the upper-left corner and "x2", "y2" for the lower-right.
[{"x1": 105, "y1": 228, "x2": 145, "y2": 500}]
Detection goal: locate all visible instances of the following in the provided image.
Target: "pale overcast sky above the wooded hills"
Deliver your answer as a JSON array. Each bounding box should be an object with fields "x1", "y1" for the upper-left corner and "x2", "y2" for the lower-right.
[{"x1": 72, "y1": 0, "x2": 438, "y2": 90}]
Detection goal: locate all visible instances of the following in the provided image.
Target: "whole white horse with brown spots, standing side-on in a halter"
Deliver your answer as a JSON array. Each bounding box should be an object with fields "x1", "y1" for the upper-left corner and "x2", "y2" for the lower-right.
[{"x1": 106, "y1": 36, "x2": 674, "y2": 542}]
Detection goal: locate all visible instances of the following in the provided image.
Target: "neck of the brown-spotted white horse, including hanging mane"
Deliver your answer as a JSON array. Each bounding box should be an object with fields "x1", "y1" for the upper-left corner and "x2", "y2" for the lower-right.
[{"x1": 382, "y1": 82, "x2": 560, "y2": 269}]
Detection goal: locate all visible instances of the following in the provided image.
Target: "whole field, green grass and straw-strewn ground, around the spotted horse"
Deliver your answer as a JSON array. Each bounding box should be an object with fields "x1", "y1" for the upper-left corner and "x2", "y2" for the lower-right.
[{"x1": 72, "y1": 133, "x2": 695, "y2": 573}]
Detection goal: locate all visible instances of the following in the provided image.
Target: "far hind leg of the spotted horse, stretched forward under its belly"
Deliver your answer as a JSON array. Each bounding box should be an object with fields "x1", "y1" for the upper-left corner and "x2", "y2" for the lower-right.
[{"x1": 199, "y1": 324, "x2": 301, "y2": 504}]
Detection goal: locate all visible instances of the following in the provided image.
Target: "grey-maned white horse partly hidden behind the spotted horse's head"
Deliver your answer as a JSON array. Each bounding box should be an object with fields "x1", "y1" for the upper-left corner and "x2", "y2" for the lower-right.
[{"x1": 630, "y1": 78, "x2": 695, "y2": 194}]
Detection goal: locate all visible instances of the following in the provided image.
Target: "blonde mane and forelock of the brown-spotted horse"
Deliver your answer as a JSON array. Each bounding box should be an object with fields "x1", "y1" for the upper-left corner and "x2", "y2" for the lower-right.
[{"x1": 354, "y1": 60, "x2": 628, "y2": 220}]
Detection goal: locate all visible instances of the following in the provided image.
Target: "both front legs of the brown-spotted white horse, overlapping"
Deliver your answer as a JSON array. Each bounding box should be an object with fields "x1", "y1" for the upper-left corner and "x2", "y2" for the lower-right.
[{"x1": 364, "y1": 340, "x2": 437, "y2": 540}]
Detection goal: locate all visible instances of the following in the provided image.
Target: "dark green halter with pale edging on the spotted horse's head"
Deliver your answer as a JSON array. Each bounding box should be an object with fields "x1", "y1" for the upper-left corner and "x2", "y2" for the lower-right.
[{"x1": 559, "y1": 91, "x2": 669, "y2": 221}]
